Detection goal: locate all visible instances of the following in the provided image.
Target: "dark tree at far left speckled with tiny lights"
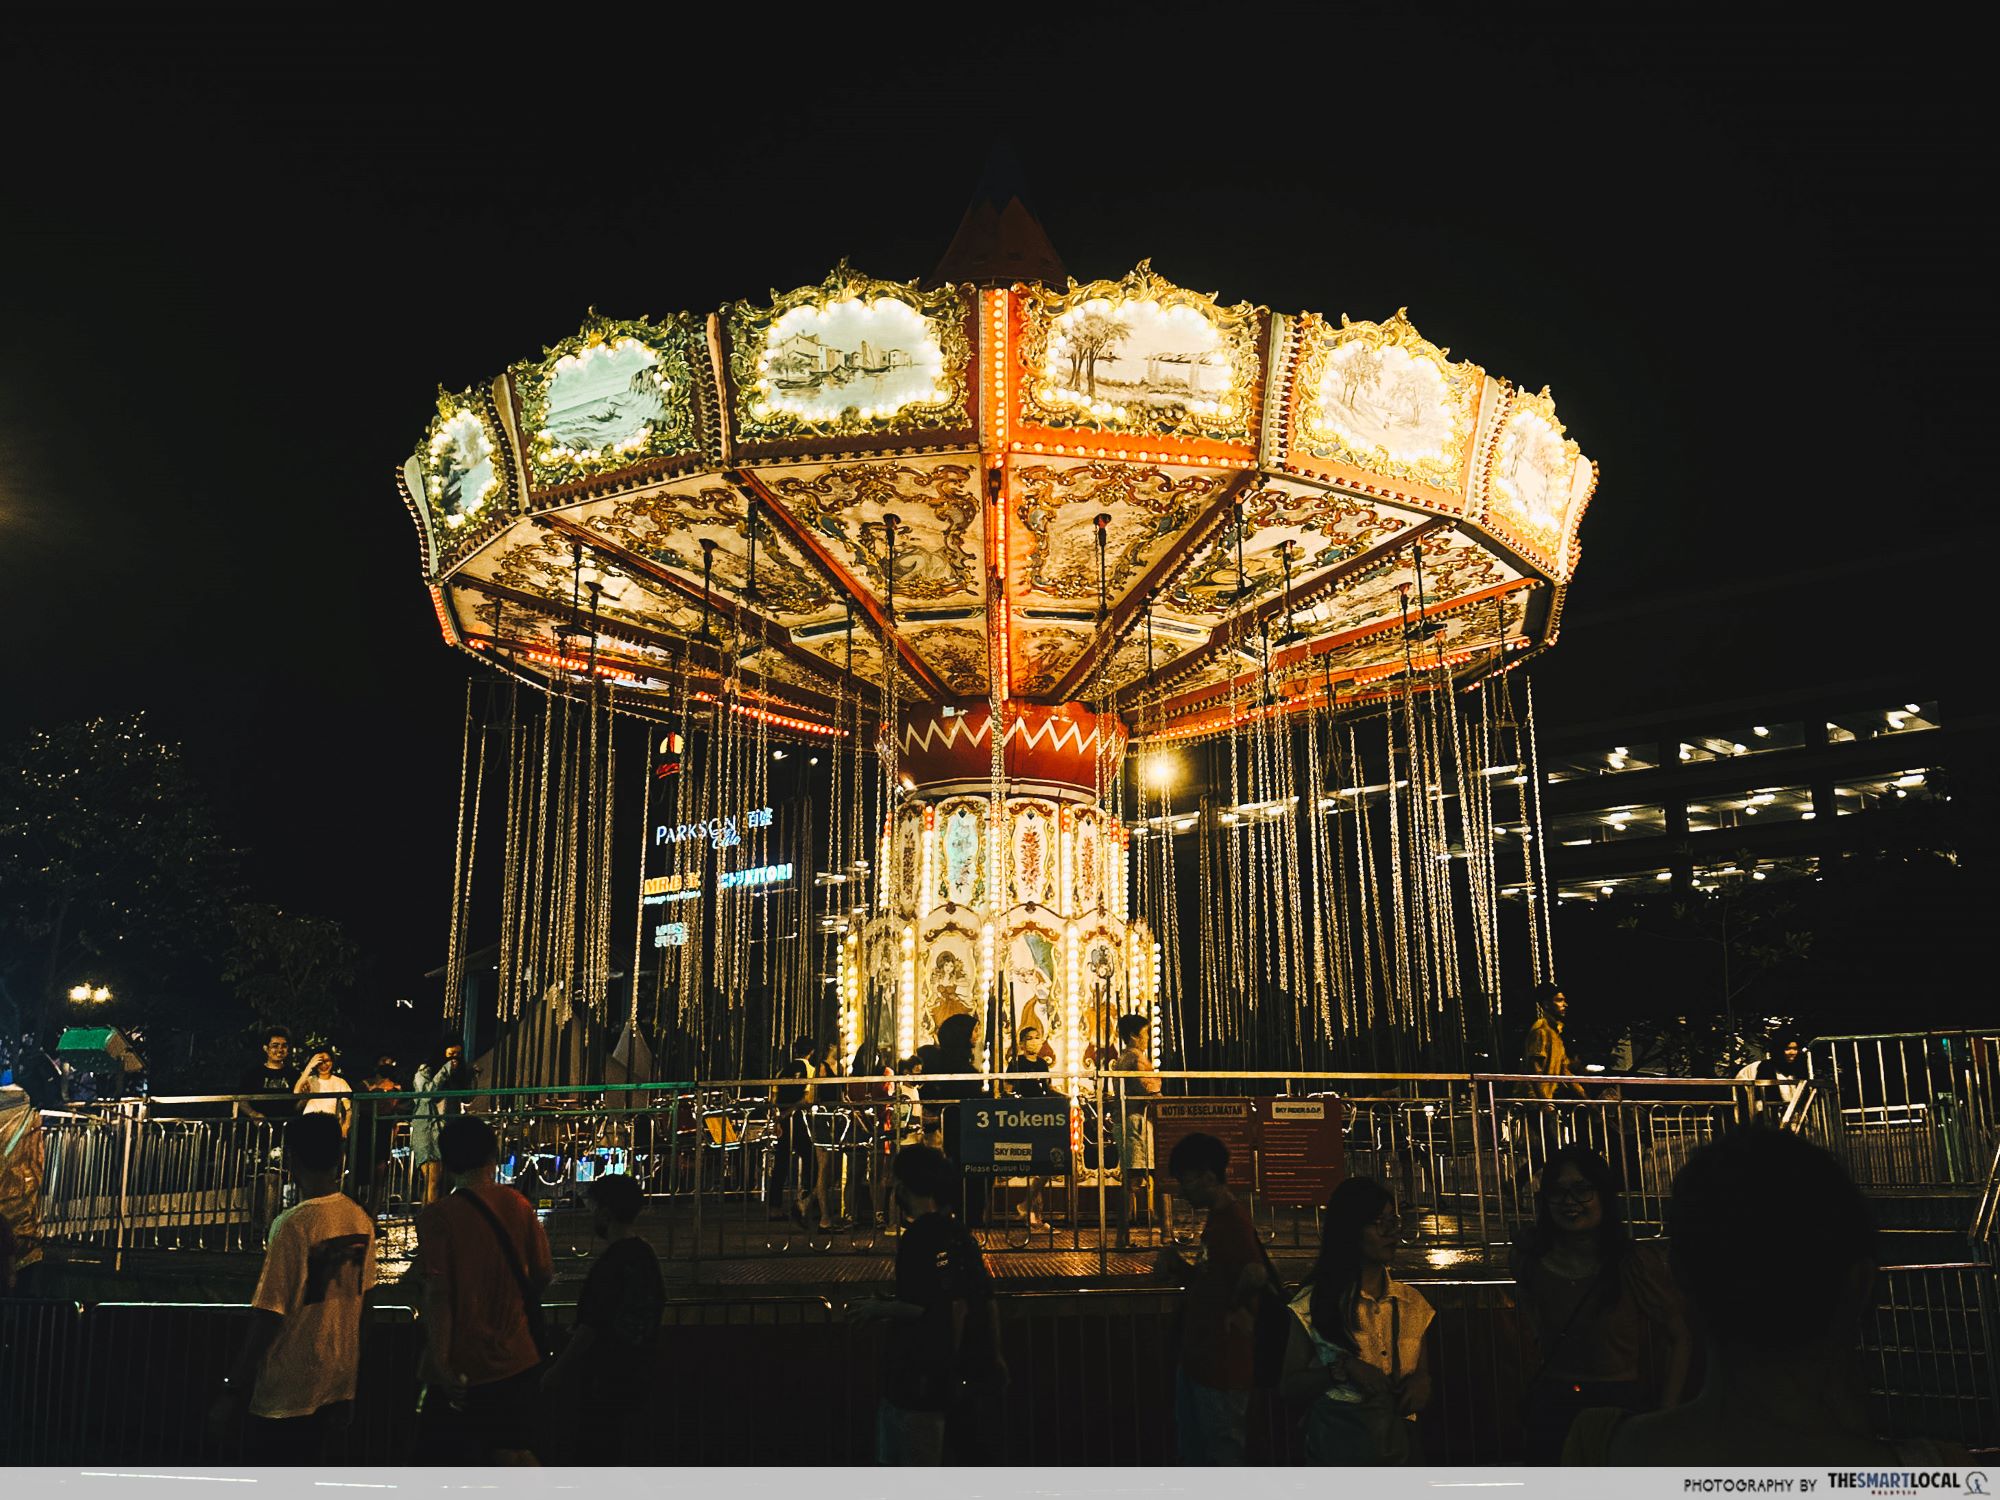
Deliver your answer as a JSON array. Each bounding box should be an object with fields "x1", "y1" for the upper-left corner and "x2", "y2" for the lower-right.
[{"x1": 0, "y1": 714, "x2": 236, "y2": 1036}]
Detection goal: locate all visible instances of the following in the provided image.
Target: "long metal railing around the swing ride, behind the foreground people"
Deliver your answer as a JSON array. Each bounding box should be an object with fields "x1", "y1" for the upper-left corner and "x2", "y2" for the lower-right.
[{"x1": 44, "y1": 1072, "x2": 1754, "y2": 1268}]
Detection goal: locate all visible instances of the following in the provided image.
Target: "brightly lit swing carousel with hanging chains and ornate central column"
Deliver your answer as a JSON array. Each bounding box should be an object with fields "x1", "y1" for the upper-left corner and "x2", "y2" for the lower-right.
[{"x1": 400, "y1": 209, "x2": 1596, "y2": 1082}]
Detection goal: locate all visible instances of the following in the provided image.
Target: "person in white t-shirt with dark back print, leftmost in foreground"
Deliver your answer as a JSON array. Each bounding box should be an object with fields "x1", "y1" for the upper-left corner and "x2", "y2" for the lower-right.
[{"x1": 210, "y1": 1114, "x2": 376, "y2": 1464}]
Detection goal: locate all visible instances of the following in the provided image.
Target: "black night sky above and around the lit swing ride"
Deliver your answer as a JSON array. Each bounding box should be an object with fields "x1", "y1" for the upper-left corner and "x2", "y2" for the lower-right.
[{"x1": 0, "y1": 6, "x2": 1992, "y2": 1012}]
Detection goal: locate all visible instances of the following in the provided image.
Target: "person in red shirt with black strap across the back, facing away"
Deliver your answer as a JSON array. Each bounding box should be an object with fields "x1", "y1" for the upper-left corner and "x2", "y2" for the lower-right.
[{"x1": 416, "y1": 1114, "x2": 556, "y2": 1464}]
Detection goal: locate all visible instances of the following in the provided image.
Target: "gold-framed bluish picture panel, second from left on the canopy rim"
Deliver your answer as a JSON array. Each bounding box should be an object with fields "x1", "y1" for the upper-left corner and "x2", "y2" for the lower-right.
[{"x1": 514, "y1": 308, "x2": 706, "y2": 490}]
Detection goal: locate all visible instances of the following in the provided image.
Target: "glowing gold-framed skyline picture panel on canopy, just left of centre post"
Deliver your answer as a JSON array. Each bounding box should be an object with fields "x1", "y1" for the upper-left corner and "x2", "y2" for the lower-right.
[{"x1": 724, "y1": 260, "x2": 972, "y2": 442}]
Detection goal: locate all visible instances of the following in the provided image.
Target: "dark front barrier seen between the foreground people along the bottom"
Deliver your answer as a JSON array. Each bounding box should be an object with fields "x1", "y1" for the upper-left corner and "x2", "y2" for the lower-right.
[{"x1": 0, "y1": 1264, "x2": 2000, "y2": 1466}]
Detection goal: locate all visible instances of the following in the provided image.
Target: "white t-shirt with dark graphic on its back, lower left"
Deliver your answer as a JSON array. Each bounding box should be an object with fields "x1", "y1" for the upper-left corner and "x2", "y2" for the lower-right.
[{"x1": 250, "y1": 1192, "x2": 376, "y2": 1416}]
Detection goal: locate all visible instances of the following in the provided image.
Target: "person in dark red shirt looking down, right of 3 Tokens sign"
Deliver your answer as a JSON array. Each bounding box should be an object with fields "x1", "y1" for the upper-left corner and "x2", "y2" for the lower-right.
[{"x1": 1160, "y1": 1132, "x2": 1270, "y2": 1464}]
